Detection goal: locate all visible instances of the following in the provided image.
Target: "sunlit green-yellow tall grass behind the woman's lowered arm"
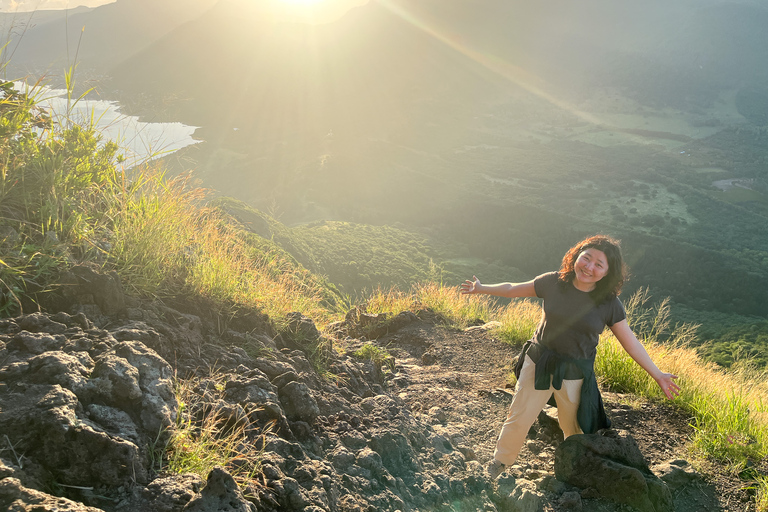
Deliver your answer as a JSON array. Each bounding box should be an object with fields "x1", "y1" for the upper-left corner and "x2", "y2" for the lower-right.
[{"x1": 595, "y1": 291, "x2": 768, "y2": 511}]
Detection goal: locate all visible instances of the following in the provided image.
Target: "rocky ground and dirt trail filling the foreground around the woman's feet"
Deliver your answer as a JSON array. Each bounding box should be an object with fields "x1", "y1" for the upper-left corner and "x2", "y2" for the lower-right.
[{"x1": 0, "y1": 269, "x2": 754, "y2": 512}]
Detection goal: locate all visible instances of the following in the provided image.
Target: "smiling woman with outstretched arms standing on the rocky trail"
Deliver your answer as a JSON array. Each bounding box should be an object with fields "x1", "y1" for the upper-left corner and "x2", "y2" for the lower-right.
[{"x1": 461, "y1": 235, "x2": 680, "y2": 478}]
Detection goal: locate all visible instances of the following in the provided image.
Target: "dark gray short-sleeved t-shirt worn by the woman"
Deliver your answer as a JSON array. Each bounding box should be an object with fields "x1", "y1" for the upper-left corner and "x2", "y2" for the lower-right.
[{"x1": 533, "y1": 272, "x2": 627, "y2": 359}]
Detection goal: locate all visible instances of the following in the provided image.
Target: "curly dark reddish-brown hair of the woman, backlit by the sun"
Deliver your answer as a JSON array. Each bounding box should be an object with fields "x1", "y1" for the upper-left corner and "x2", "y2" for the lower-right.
[{"x1": 558, "y1": 235, "x2": 629, "y2": 304}]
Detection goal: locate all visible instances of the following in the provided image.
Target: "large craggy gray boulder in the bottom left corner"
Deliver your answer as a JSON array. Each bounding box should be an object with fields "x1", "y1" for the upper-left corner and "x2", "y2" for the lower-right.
[{"x1": 0, "y1": 313, "x2": 177, "y2": 492}]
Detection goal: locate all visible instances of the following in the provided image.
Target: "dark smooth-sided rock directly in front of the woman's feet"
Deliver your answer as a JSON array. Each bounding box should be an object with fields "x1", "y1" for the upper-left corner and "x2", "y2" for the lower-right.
[{"x1": 555, "y1": 430, "x2": 674, "y2": 512}]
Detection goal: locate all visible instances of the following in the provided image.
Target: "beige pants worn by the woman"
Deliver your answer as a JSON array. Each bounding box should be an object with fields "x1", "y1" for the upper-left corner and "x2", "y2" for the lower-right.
[{"x1": 493, "y1": 356, "x2": 584, "y2": 465}]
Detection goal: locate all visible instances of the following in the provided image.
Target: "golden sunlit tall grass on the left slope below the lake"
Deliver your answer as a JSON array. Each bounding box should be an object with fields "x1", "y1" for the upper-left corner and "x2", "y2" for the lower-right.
[{"x1": 111, "y1": 169, "x2": 328, "y2": 324}]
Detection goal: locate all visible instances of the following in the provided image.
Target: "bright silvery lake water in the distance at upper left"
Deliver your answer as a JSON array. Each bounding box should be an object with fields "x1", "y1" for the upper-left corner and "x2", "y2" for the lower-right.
[{"x1": 15, "y1": 82, "x2": 202, "y2": 168}]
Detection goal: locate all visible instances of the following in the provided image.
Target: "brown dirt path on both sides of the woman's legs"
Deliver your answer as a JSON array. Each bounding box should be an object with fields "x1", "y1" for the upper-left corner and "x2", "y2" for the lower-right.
[{"x1": 378, "y1": 322, "x2": 755, "y2": 512}]
